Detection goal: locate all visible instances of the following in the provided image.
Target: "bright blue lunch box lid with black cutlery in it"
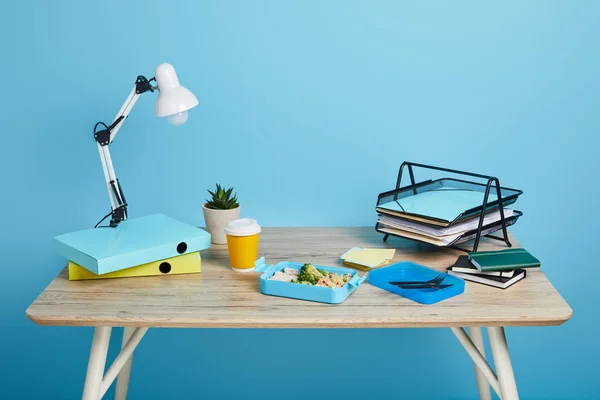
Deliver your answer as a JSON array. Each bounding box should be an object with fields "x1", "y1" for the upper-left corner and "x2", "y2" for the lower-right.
[{"x1": 369, "y1": 261, "x2": 465, "y2": 304}]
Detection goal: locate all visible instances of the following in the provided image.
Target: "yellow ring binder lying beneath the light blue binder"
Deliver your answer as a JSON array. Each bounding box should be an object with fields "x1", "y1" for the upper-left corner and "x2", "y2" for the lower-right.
[{"x1": 69, "y1": 252, "x2": 202, "y2": 281}]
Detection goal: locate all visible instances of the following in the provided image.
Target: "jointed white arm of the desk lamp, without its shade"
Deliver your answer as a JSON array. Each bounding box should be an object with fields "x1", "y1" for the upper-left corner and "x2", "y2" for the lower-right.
[{"x1": 94, "y1": 75, "x2": 158, "y2": 227}]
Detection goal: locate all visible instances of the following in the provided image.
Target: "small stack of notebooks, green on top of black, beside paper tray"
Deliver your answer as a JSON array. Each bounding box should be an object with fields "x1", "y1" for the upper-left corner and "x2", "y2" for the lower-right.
[{"x1": 446, "y1": 248, "x2": 541, "y2": 289}]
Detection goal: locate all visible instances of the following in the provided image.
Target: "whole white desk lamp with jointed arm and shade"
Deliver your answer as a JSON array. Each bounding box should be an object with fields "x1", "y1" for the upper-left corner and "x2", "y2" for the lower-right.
[{"x1": 94, "y1": 64, "x2": 198, "y2": 227}]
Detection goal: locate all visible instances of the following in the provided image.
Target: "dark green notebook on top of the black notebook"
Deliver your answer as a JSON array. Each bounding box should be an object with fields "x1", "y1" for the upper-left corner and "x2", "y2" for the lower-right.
[{"x1": 469, "y1": 248, "x2": 541, "y2": 271}]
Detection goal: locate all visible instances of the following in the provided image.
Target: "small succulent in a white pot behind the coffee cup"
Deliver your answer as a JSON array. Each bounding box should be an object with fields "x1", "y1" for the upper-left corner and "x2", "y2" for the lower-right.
[{"x1": 202, "y1": 184, "x2": 240, "y2": 244}]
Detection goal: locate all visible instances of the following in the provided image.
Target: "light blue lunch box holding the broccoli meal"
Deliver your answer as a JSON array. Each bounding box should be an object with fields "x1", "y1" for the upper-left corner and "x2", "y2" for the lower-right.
[{"x1": 254, "y1": 257, "x2": 367, "y2": 304}]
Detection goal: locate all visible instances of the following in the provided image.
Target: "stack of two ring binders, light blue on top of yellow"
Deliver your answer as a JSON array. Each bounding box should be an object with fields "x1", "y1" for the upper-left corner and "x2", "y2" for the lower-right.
[{"x1": 54, "y1": 214, "x2": 210, "y2": 280}]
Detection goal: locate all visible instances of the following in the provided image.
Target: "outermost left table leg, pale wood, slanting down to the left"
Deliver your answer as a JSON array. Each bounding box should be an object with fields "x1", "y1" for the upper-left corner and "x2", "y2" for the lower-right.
[{"x1": 82, "y1": 326, "x2": 112, "y2": 400}]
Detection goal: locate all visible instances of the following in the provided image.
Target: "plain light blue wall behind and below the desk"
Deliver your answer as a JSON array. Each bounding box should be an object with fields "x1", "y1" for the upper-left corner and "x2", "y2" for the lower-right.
[{"x1": 0, "y1": 0, "x2": 600, "y2": 400}]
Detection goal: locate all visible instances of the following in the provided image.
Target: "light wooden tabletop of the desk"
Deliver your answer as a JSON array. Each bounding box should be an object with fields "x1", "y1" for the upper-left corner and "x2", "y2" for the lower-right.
[{"x1": 27, "y1": 227, "x2": 572, "y2": 328}]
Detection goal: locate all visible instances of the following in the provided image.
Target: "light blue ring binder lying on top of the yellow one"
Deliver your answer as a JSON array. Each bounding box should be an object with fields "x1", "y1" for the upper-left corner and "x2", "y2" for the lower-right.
[{"x1": 53, "y1": 214, "x2": 210, "y2": 275}]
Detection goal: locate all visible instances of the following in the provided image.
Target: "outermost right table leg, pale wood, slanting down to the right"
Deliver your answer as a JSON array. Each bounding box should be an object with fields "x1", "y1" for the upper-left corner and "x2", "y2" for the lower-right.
[{"x1": 488, "y1": 327, "x2": 519, "y2": 400}]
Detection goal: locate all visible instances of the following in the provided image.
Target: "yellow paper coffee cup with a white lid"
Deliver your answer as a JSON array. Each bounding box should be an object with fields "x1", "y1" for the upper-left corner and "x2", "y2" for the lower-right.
[{"x1": 225, "y1": 218, "x2": 260, "y2": 272}]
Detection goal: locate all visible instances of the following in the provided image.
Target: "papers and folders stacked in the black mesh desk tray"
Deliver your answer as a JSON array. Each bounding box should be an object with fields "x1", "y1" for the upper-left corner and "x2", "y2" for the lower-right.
[{"x1": 376, "y1": 184, "x2": 522, "y2": 247}]
